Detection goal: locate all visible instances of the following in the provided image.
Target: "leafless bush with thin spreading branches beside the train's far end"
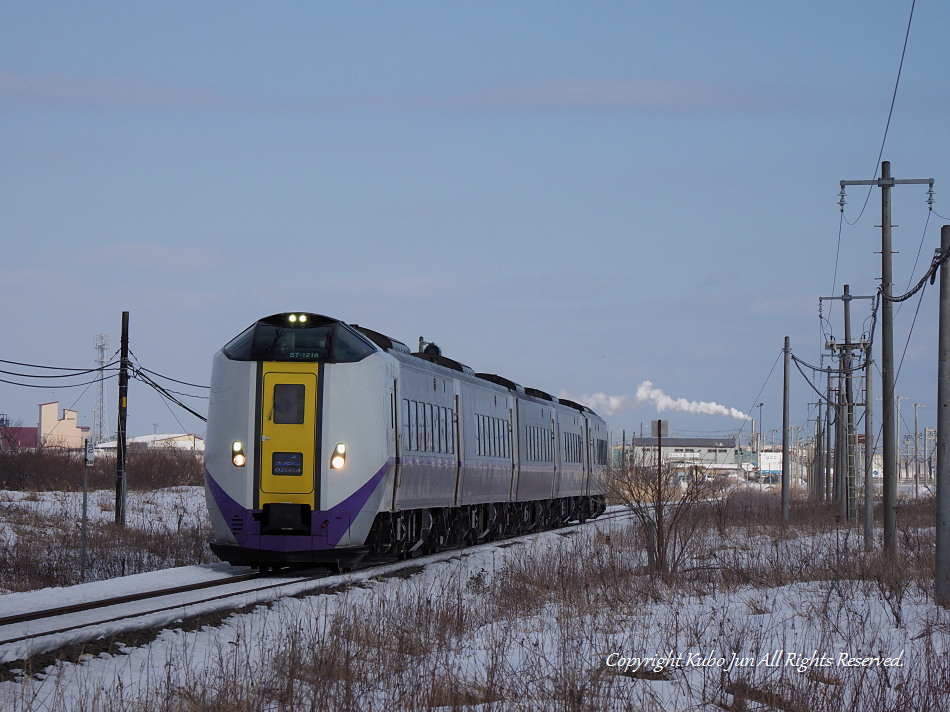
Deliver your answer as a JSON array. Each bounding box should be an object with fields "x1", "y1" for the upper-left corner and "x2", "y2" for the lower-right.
[{"x1": 604, "y1": 454, "x2": 731, "y2": 578}]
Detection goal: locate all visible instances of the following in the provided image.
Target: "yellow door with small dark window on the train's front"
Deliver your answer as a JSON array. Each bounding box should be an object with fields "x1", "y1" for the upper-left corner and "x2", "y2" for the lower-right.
[{"x1": 260, "y1": 364, "x2": 317, "y2": 509}]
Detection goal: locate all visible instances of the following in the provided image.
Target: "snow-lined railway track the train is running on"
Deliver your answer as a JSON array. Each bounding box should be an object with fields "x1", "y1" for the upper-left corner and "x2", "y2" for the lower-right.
[{"x1": 0, "y1": 511, "x2": 629, "y2": 670}]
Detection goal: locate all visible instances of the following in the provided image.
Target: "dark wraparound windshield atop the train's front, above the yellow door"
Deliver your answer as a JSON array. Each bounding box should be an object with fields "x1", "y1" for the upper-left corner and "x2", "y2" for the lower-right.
[{"x1": 224, "y1": 314, "x2": 376, "y2": 363}]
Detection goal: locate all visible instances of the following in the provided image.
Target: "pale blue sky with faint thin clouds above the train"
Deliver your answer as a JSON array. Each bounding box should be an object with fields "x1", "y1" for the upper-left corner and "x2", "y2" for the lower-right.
[{"x1": 0, "y1": 0, "x2": 950, "y2": 450}]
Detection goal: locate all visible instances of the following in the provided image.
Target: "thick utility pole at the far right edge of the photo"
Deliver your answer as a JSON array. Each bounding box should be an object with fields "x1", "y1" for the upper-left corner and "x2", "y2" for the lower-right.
[{"x1": 934, "y1": 225, "x2": 950, "y2": 608}]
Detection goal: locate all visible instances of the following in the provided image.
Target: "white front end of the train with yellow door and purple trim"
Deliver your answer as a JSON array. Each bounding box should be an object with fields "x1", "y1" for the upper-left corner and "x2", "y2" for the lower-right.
[{"x1": 205, "y1": 312, "x2": 395, "y2": 568}]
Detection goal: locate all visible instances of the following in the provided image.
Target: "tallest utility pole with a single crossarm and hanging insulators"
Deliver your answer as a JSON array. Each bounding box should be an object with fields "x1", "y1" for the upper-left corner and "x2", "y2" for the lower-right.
[{"x1": 839, "y1": 161, "x2": 934, "y2": 554}]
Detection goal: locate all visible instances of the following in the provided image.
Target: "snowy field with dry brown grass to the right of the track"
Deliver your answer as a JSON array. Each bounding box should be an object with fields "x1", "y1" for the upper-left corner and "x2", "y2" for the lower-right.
[{"x1": 0, "y1": 492, "x2": 950, "y2": 712}]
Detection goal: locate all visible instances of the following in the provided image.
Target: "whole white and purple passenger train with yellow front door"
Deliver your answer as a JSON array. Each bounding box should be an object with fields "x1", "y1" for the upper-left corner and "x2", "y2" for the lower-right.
[{"x1": 204, "y1": 312, "x2": 608, "y2": 570}]
